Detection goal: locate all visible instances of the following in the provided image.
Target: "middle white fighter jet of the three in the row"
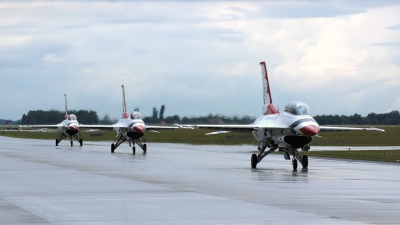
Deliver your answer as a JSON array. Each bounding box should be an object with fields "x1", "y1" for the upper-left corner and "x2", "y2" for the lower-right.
[{"x1": 85, "y1": 85, "x2": 179, "y2": 153}]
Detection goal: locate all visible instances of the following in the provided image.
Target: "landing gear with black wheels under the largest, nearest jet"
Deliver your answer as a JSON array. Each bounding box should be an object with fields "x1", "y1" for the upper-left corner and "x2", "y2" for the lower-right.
[{"x1": 251, "y1": 140, "x2": 308, "y2": 170}]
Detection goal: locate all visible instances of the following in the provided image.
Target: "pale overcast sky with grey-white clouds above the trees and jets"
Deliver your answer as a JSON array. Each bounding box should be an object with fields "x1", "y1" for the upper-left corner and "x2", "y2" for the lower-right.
[{"x1": 0, "y1": 0, "x2": 400, "y2": 121}]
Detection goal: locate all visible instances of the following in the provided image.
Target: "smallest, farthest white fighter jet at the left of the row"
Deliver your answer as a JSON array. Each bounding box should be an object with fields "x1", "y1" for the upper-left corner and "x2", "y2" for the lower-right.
[{"x1": 21, "y1": 94, "x2": 83, "y2": 146}]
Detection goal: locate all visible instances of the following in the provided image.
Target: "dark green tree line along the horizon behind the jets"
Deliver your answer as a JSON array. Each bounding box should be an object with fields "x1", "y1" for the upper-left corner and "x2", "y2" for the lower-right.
[{"x1": 21, "y1": 105, "x2": 400, "y2": 125}]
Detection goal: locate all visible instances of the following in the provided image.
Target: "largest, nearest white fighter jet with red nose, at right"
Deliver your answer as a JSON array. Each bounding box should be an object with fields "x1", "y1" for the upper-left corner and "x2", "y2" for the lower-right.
[{"x1": 196, "y1": 62, "x2": 384, "y2": 169}]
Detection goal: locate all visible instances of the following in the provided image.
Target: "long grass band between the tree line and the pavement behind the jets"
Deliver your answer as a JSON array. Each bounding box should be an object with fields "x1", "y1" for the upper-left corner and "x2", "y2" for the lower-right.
[{"x1": 0, "y1": 126, "x2": 400, "y2": 146}]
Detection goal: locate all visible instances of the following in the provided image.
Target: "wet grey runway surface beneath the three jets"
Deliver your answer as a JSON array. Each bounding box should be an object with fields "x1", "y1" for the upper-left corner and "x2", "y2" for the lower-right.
[{"x1": 0, "y1": 134, "x2": 400, "y2": 225}]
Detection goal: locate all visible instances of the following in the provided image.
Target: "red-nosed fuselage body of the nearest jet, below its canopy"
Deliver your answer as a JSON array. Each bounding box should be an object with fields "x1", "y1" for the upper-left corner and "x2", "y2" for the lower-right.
[{"x1": 253, "y1": 112, "x2": 319, "y2": 148}]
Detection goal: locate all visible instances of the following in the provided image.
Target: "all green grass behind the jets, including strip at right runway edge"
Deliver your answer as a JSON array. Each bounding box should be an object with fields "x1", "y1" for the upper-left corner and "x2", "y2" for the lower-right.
[{"x1": 0, "y1": 126, "x2": 400, "y2": 162}]
